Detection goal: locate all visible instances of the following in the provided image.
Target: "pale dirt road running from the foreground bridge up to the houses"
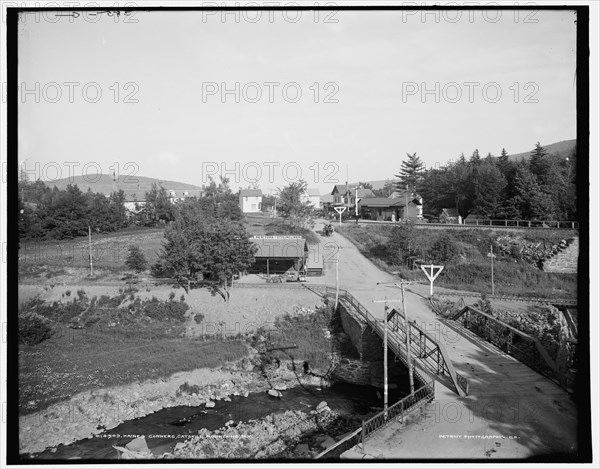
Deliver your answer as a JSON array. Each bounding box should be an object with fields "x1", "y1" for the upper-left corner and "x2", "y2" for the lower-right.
[{"x1": 314, "y1": 222, "x2": 577, "y2": 459}]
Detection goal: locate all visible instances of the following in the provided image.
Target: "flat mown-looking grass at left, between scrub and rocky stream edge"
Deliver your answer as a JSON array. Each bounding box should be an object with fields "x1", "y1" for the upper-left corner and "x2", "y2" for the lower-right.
[{"x1": 19, "y1": 325, "x2": 247, "y2": 414}]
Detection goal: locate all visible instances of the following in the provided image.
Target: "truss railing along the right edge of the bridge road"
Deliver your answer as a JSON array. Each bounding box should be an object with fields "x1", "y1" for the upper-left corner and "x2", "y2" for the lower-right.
[{"x1": 449, "y1": 306, "x2": 577, "y2": 390}]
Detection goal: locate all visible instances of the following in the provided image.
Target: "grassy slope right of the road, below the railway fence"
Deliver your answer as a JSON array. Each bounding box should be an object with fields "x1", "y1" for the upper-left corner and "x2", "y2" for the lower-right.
[{"x1": 337, "y1": 224, "x2": 577, "y2": 298}]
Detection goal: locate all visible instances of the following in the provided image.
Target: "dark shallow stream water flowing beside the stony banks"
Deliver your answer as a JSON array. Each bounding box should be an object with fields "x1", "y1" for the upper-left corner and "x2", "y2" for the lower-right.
[{"x1": 31, "y1": 383, "x2": 407, "y2": 460}]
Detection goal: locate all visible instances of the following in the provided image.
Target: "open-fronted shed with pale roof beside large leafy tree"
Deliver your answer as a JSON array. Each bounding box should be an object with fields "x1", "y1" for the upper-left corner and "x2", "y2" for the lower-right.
[{"x1": 249, "y1": 236, "x2": 308, "y2": 275}]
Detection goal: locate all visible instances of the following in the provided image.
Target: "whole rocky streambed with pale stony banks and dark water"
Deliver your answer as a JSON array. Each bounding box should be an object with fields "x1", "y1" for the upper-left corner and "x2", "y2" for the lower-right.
[{"x1": 19, "y1": 346, "x2": 380, "y2": 460}]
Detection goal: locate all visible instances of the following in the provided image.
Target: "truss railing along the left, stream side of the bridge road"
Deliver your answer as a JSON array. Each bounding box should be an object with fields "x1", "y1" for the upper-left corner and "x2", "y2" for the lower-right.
[{"x1": 324, "y1": 287, "x2": 469, "y2": 396}]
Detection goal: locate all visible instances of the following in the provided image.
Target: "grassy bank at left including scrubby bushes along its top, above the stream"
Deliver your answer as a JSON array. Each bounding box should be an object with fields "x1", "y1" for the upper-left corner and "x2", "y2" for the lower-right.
[{"x1": 19, "y1": 290, "x2": 248, "y2": 414}]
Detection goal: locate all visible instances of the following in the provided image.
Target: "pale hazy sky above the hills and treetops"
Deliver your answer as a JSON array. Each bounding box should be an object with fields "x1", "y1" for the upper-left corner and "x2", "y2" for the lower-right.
[{"x1": 19, "y1": 10, "x2": 576, "y2": 192}]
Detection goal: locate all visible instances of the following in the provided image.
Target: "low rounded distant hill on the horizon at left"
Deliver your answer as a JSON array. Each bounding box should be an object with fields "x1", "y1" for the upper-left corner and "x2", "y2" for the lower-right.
[{"x1": 44, "y1": 174, "x2": 202, "y2": 194}]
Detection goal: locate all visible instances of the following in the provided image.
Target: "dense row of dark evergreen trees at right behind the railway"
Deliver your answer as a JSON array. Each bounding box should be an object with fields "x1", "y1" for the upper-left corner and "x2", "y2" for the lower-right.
[{"x1": 396, "y1": 142, "x2": 577, "y2": 220}]
